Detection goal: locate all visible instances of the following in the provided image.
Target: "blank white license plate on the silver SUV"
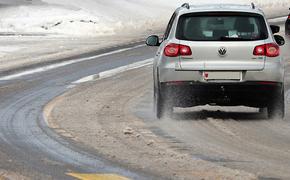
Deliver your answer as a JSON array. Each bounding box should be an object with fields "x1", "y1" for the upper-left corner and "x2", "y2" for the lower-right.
[{"x1": 203, "y1": 71, "x2": 242, "y2": 80}]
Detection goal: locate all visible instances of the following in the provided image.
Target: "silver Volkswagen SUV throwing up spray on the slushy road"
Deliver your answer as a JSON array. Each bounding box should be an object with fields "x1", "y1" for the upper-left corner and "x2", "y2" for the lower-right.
[{"x1": 146, "y1": 3, "x2": 285, "y2": 118}]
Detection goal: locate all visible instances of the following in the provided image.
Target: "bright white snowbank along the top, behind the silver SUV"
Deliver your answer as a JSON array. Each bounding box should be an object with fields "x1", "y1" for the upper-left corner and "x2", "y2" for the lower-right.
[{"x1": 0, "y1": 0, "x2": 290, "y2": 36}]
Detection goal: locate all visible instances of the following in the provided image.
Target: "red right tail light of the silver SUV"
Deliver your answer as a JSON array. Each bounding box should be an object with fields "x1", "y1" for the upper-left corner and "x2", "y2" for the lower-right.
[{"x1": 253, "y1": 43, "x2": 280, "y2": 57}]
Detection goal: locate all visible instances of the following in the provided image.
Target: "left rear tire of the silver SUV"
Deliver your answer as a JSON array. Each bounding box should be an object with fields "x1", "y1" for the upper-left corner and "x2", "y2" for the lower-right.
[{"x1": 154, "y1": 85, "x2": 173, "y2": 119}]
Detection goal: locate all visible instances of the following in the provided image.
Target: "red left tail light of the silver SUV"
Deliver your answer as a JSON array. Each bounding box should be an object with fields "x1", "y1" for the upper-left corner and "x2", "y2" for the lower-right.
[{"x1": 164, "y1": 43, "x2": 192, "y2": 57}]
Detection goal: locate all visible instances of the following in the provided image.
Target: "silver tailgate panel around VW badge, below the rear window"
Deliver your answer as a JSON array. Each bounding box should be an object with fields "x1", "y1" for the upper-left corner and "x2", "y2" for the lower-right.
[{"x1": 177, "y1": 41, "x2": 266, "y2": 71}]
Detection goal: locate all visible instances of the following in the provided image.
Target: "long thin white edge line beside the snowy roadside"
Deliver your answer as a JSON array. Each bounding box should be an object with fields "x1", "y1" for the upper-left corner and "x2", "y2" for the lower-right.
[{"x1": 0, "y1": 45, "x2": 145, "y2": 81}]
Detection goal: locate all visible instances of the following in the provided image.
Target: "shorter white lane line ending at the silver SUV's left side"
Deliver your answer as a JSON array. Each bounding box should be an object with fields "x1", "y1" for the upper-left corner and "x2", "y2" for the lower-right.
[{"x1": 72, "y1": 58, "x2": 153, "y2": 84}]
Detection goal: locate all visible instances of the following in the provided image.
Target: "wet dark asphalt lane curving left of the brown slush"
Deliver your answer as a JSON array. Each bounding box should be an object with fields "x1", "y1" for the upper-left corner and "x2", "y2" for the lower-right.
[{"x1": 0, "y1": 44, "x2": 154, "y2": 179}]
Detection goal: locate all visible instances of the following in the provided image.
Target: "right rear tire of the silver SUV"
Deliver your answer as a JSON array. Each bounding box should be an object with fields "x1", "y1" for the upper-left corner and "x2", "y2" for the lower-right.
[{"x1": 267, "y1": 90, "x2": 285, "y2": 119}]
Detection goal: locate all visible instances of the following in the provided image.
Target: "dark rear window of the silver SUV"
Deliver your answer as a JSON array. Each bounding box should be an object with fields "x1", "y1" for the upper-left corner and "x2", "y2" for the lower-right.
[{"x1": 176, "y1": 12, "x2": 268, "y2": 41}]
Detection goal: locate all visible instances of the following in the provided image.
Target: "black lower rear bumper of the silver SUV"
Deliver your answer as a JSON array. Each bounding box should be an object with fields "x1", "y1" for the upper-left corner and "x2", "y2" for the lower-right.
[{"x1": 160, "y1": 81, "x2": 283, "y2": 107}]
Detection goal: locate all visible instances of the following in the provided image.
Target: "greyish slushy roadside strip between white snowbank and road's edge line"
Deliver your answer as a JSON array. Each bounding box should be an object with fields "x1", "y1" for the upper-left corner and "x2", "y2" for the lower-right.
[{"x1": 0, "y1": 35, "x2": 144, "y2": 73}]
